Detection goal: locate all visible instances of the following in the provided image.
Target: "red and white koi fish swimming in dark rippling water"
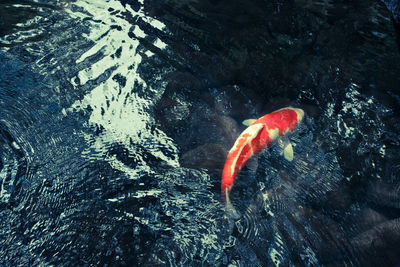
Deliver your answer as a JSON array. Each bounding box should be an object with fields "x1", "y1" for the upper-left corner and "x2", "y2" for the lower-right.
[{"x1": 221, "y1": 107, "x2": 304, "y2": 215}]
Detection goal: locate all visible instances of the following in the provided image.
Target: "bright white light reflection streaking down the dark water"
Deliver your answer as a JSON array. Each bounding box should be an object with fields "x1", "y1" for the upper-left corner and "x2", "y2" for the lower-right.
[{"x1": 67, "y1": 0, "x2": 179, "y2": 179}]
